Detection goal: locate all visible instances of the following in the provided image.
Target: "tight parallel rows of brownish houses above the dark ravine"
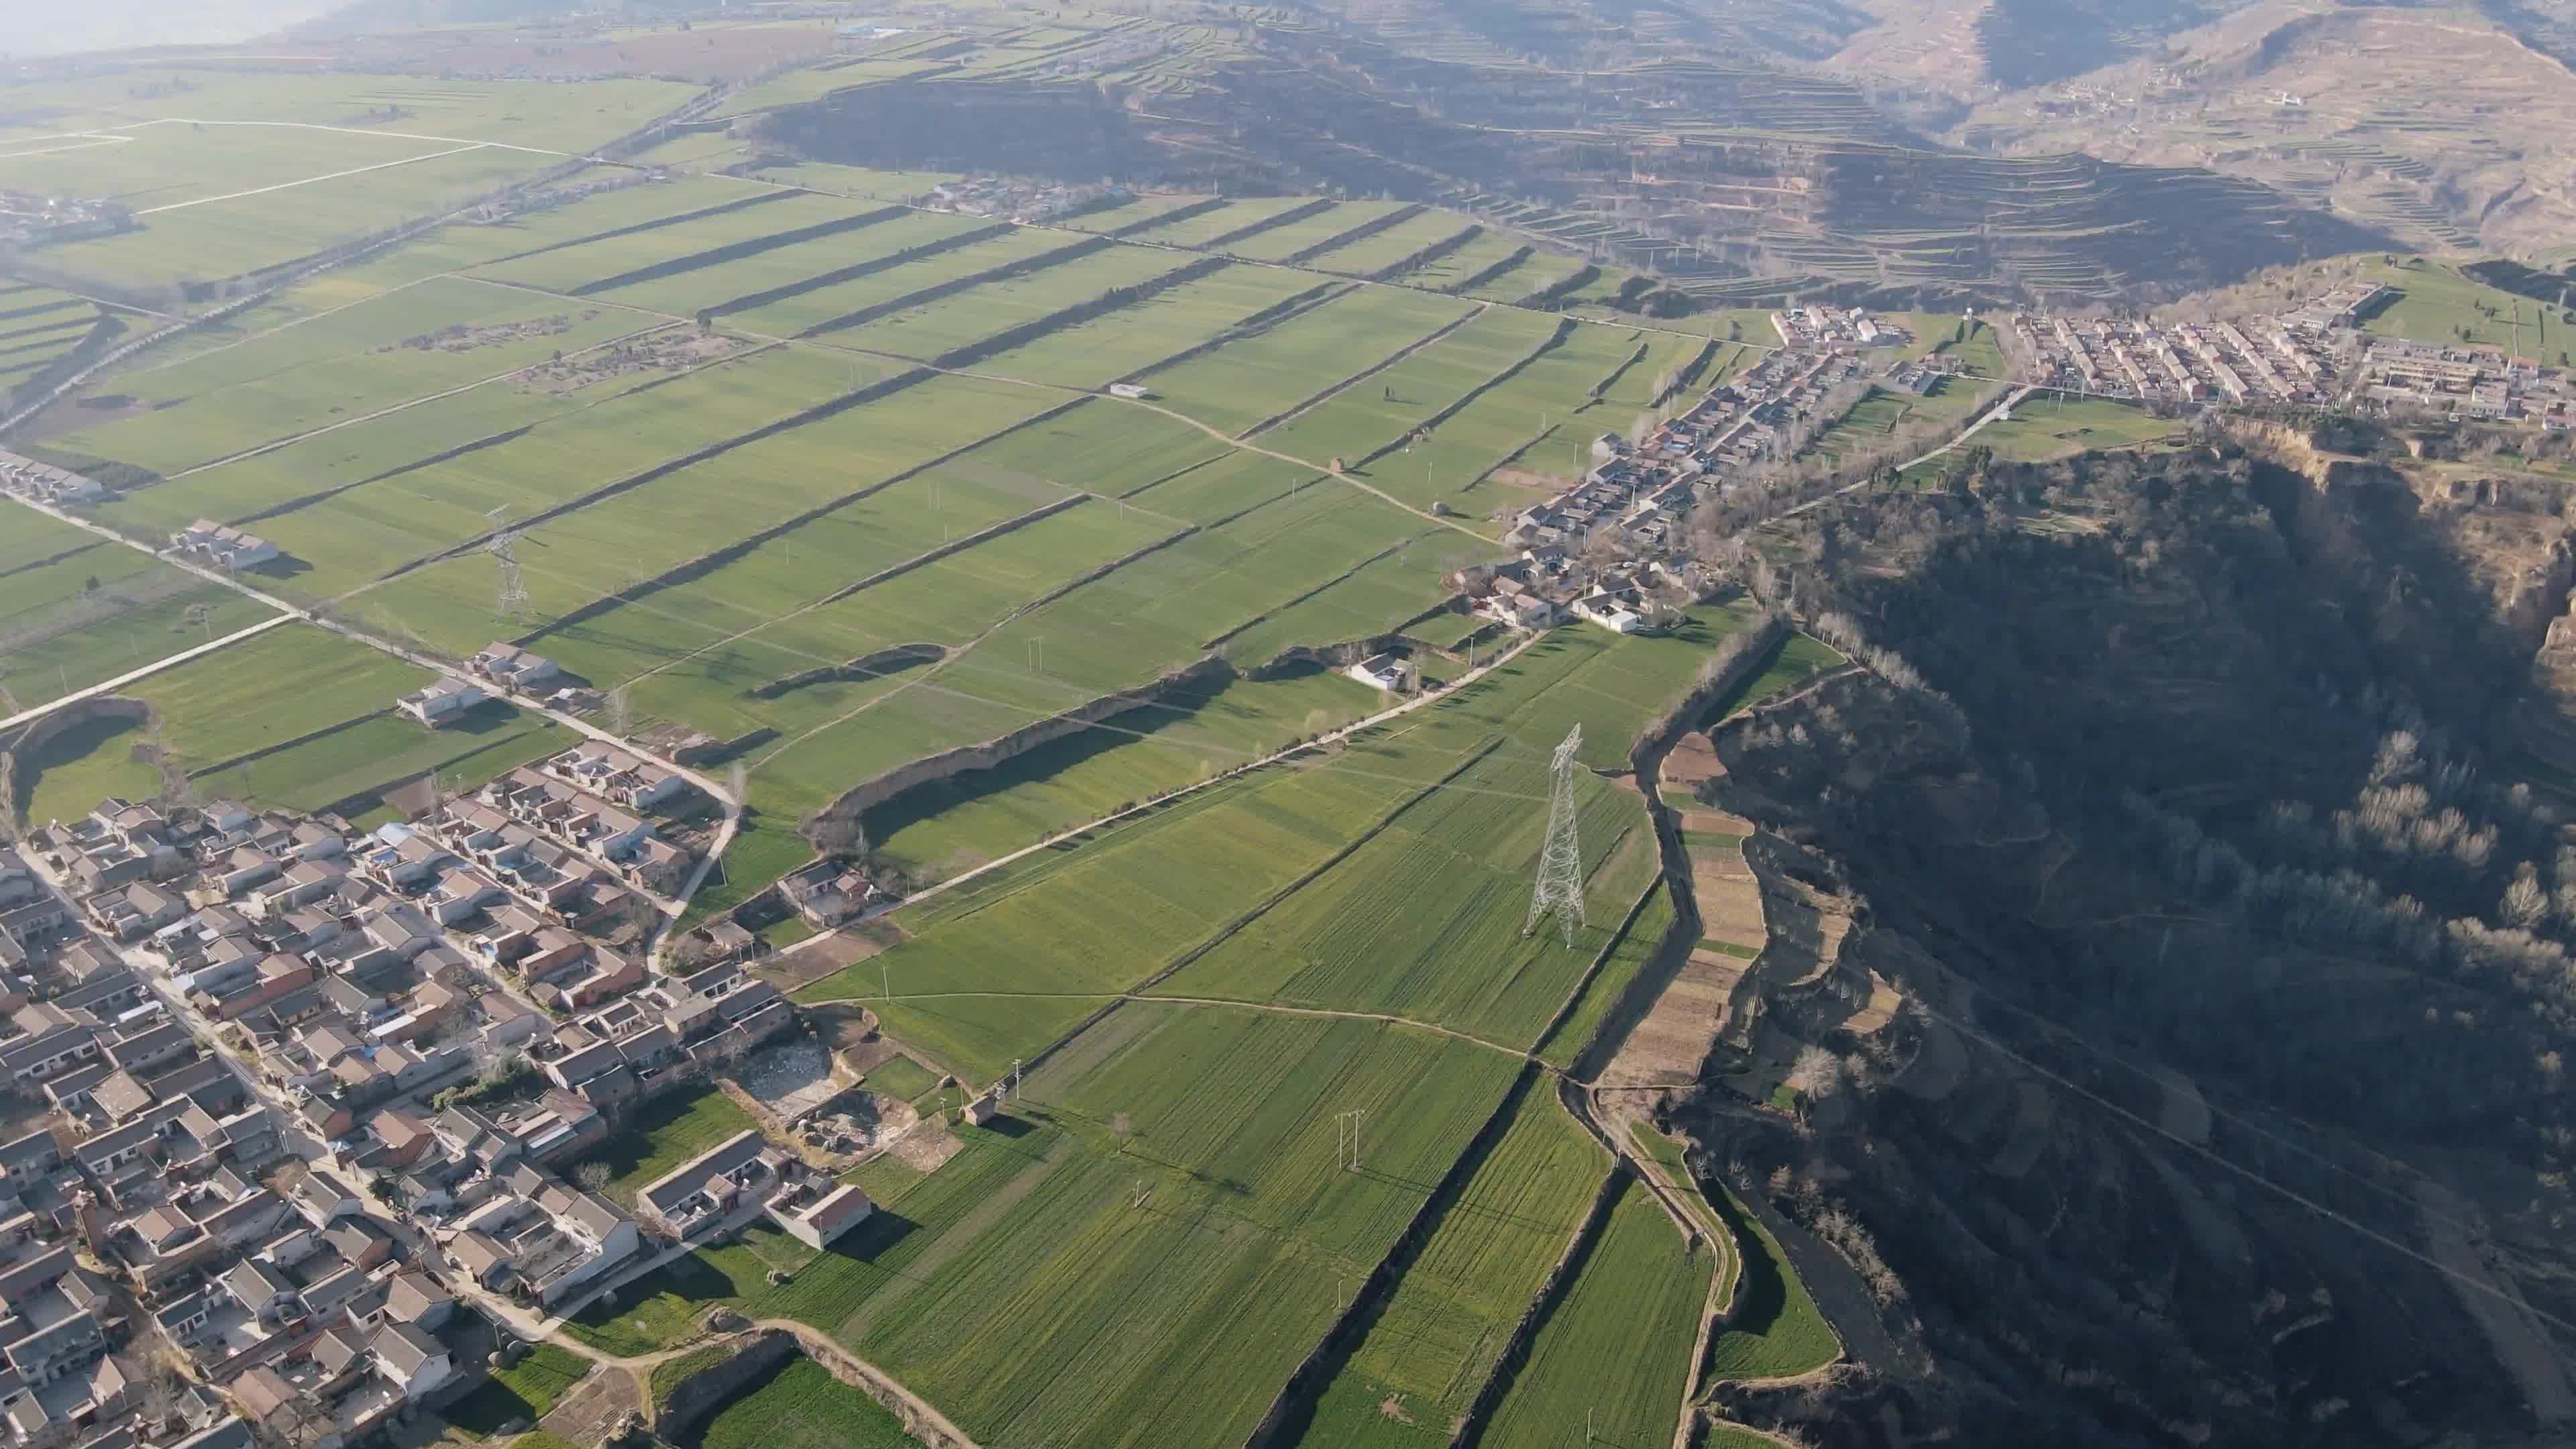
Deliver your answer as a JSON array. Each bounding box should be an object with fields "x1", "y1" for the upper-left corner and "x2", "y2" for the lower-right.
[{"x1": 2012, "y1": 312, "x2": 2342, "y2": 405}]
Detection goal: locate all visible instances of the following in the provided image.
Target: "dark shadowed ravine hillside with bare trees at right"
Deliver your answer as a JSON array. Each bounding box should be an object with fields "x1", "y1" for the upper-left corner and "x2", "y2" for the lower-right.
[{"x1": 1695, "y1": 436, "x2": 2576, "y2": 1446}]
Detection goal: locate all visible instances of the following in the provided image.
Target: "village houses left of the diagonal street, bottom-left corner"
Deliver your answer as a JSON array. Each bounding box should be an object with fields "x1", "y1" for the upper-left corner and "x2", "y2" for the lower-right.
[{"x1": 0, "y1": 835, "x2": 484, "y2": 1449}]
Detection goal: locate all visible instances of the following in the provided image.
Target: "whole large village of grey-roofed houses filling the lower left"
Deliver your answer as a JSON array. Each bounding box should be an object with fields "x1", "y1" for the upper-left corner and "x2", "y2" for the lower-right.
[{"x1": 0, "y1": 763, "x2": 835, "y2": 1449}]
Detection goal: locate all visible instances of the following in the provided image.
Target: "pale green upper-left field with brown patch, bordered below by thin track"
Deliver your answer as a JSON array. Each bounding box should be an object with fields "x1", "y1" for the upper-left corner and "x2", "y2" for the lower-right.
[{"x1": 62, "y1": 278, "x2": 657, "y2": 474}]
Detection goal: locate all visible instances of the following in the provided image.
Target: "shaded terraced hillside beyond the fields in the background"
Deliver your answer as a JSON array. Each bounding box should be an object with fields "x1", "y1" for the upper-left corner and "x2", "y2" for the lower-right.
[{"x1": 767, "y1": 36, "x2": 2385, "y2": 301}]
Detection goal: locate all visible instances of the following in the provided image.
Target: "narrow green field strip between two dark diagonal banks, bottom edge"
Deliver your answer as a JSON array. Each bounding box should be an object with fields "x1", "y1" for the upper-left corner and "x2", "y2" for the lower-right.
[{"x1": 1298, "y1": 1080, "x2": 1610, "y2": 1449}]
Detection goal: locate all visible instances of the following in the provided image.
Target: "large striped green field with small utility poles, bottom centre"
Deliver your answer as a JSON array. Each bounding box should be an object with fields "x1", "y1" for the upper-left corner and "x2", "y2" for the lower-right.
[{"x1": 843, "y1": 1006, "x2": 1517, "y2": 1446}]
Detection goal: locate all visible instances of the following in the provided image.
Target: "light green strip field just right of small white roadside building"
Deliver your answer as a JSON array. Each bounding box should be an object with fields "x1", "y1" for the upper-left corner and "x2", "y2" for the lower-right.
[{"x1": 1144, "y1": 288, "x2": 1473, "y2": 433}]
